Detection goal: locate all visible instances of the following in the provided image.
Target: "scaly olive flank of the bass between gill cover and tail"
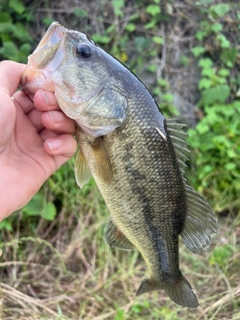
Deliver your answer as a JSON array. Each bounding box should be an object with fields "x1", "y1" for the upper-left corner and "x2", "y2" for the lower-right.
[{"x1": 79, "y1": 89, "x2": 186, "y2": 277}]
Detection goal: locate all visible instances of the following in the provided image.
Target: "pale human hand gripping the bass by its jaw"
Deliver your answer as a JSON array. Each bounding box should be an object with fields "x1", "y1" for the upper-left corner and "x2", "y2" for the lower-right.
[{"x1": 0, "y1": 61, "x2": 77, "y2": 221}]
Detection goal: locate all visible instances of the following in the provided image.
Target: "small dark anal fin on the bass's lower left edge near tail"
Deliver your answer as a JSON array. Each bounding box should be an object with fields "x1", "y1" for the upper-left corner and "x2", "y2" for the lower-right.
[{"x1": 104, "y1": 220, "x2": 134, "y2": 251}]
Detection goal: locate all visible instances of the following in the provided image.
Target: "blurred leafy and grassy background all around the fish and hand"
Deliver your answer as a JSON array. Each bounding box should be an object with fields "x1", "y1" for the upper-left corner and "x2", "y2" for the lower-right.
[{"x1": 0, "y1": 0, "x2": 240, "y2": 320}]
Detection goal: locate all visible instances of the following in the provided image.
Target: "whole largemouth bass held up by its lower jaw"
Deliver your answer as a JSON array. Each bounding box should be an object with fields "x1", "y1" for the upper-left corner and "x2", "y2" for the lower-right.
[{"x1": 21, "y1": 22, "x2": 217, "y2": 308}]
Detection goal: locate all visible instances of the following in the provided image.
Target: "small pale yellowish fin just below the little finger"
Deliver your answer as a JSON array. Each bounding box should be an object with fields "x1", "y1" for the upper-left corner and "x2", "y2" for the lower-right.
[{"x1": 74, "y1": 149, "x2": 92, "y2": 188}]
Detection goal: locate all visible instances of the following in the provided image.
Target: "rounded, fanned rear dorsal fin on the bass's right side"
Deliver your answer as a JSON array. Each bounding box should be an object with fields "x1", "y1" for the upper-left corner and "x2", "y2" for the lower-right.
[{"x1": 181, "y1": 185, "x2": 217, "y2": 253}]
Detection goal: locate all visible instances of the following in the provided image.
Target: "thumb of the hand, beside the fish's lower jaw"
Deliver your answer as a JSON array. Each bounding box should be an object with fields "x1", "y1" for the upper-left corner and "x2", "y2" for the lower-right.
[{"x1": 0, "y1": 60, "x2": 26, "y2": 96}]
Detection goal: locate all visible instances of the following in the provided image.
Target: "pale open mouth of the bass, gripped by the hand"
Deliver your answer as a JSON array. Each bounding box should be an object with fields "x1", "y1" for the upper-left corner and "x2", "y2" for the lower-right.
[{"x1": 20, "y1": 22, "x2": 66, "y2": 93}]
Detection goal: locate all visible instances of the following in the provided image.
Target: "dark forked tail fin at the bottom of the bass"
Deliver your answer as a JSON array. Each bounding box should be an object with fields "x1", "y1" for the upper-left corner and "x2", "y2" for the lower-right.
[{"x1": 137, "y1": 275, "x2": 198, "y2": 308}]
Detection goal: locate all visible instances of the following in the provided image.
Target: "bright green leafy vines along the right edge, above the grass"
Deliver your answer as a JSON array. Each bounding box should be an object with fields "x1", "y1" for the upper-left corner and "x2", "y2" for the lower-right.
[{"x1": 189, "y1": 1, "x2": 240, "y2": 210}]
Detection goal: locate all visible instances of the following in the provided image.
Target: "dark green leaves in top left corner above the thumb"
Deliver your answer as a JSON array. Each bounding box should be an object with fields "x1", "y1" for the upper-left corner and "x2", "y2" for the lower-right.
[{"x1": 0, "y1": 0, "x2": 33, "y2": 62}]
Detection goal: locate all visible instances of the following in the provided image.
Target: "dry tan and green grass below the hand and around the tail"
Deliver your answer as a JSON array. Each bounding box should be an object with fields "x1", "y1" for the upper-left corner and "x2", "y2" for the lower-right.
[{"x1": 0, "y1": 160, "x2": 240, "y2": 320}]
